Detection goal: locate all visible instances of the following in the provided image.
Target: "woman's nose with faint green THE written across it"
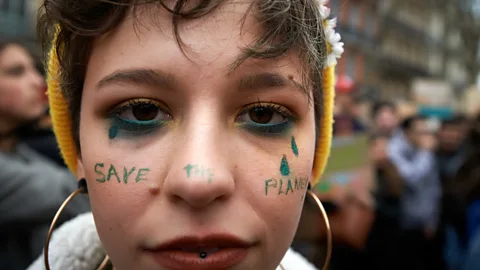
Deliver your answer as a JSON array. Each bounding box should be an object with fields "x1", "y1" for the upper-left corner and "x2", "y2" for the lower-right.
[{"x1": 163, "y1": 115, "x2": 235, "y2": 209}]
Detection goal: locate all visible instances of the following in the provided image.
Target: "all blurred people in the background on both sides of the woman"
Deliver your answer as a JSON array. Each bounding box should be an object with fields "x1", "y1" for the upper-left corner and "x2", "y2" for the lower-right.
[{"x1": 0, "y1": 37, "x2": 480, "y2": 270}]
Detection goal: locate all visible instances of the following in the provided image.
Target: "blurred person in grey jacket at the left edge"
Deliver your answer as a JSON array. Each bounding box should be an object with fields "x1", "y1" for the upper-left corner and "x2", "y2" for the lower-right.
[{"x1": 0, "y1": 41, "x2": 89, "y2": 270}]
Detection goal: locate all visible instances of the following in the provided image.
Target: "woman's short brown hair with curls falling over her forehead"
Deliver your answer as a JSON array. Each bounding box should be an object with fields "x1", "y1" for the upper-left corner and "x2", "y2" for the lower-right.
[{"x1": 37, "y1": 0, "x2": 327, "y2": 150}]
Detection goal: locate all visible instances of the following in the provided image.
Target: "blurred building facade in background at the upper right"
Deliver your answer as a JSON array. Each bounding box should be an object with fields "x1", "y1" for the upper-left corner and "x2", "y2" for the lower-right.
[{"x1": 330, "y1": 0, "x2": 473, "y2": 107}]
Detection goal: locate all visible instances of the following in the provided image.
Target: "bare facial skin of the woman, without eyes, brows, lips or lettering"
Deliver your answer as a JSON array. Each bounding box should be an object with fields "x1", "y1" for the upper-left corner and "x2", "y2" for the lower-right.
[{"x1": 79, "y1": 3, "x2": 315, "y2": 270}]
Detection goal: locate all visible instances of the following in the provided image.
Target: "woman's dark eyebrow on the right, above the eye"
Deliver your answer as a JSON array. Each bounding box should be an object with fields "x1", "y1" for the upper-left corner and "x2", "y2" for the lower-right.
[{"x1": 238, "y1": 72, "x2": 304, "y2": 91}]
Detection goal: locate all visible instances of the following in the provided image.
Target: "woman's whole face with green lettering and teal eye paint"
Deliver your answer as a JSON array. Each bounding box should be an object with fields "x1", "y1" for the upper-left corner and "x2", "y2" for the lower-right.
[{"x1": 79, "y1": 3, "x2": 315, "y2": 270}]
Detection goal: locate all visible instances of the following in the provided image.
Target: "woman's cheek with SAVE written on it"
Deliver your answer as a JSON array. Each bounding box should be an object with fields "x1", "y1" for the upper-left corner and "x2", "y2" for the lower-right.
[{"x1": 82, "y1": 151, "x2": 161, "y2": 258}]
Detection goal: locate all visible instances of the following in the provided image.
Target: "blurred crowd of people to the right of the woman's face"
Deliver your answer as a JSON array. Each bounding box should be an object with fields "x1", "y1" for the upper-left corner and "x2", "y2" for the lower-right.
[{"x1": 296, "y1": 76, "x2": 480, "y2": 270}]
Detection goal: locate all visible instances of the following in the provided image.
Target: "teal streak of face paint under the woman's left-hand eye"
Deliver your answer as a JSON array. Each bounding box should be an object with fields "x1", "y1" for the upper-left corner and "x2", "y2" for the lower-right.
[{"x1": 108, "y1": 117, "x2": 168, "y2": 139}]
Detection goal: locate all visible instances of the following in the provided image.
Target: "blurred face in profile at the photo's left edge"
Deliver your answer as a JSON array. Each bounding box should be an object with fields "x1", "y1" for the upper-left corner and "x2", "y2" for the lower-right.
[{"x1": 0, "y1": 45, "x2": 45, "y2": 129}]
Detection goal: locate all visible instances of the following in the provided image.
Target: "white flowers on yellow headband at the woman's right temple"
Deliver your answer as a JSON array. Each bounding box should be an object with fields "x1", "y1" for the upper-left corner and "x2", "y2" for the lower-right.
[{"x1": 317, "y1": 0, "x2": 344, "y2": 67}]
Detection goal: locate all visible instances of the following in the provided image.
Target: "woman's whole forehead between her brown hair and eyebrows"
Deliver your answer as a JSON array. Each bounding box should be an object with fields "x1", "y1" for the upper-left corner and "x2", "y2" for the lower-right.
[{"x1": 85, "y1": 1, "x2": 310, "y2": 94}]
